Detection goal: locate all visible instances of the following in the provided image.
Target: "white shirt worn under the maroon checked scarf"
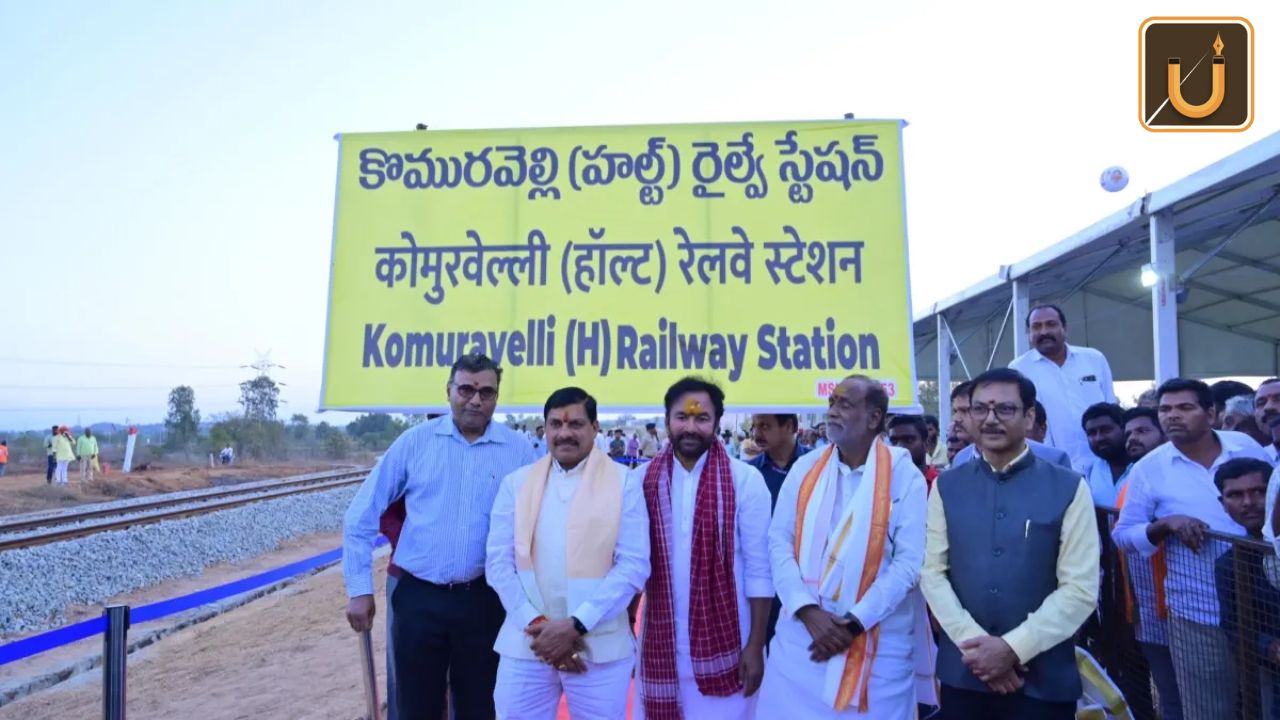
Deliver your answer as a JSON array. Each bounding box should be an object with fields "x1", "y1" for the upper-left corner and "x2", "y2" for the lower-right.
[{"x1": 631, "y1": 454, "x2": 773, "y2": 679}]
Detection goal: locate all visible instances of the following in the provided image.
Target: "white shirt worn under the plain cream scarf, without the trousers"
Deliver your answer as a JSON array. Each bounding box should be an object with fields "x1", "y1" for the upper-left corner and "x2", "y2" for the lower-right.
[{"x1": 485, "y1": 460, "x2": 649, "y2": 659}]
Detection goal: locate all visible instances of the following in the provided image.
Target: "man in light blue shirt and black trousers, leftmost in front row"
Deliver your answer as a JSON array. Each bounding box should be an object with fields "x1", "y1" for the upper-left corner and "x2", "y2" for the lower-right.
[{"x1": 342, "y1": 354, "x2": 535, "y2": 719}]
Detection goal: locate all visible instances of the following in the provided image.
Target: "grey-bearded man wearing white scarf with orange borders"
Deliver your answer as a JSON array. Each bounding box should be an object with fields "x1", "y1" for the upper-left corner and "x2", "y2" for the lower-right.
[{"x1": 759, "y1": 377, "x2": 937, "y2": 720}]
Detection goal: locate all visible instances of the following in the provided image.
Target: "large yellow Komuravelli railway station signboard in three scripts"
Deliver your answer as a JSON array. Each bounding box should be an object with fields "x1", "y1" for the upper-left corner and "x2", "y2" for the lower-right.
[{"x1": 321, "y1": 120, "x2": 915, "y2": 411}]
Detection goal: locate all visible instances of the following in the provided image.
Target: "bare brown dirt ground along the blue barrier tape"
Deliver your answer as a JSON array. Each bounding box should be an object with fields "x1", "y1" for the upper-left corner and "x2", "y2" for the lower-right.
[{"x1": 0, "y1": 534, "x2": 387, "y2": 720}]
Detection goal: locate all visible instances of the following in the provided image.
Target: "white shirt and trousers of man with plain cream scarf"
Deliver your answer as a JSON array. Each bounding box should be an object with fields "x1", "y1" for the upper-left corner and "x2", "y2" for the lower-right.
[{"x1": 485, "y1": 451, "x2": 649, "y2": 720}]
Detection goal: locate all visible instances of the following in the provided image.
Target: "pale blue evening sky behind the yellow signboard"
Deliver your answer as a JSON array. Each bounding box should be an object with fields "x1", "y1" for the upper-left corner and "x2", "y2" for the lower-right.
[{"x1": 0, "y1": 0, "x2": 1280, "y2": 428}]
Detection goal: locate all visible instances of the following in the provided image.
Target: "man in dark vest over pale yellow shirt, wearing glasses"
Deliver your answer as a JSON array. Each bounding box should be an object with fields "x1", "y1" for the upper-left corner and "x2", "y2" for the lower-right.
[{"x1": 920, "y1": 369, "x2": 1100, "y2": 720}]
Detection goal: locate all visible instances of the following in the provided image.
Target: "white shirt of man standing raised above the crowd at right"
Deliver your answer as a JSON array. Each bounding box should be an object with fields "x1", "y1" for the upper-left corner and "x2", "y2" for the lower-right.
[{"x1": 1009, "y1": 343, "x2": 1116, "y2": 473}]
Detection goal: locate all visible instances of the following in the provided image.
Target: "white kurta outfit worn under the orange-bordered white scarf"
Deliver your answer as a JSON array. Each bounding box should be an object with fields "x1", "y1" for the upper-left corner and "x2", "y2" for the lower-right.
[{"x1": 759, "y1": 446, "x2": 937, "y2": 720}]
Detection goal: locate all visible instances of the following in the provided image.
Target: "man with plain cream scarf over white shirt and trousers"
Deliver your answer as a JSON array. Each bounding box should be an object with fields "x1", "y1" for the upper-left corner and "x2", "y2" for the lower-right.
[{"x1": 485, "y1": 388, "x2": 649, "y2": 720}]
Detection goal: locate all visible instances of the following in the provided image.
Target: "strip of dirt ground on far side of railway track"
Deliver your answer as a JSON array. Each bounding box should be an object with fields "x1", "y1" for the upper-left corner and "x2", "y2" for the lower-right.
[{"x1": 0, "y1": 462, "x2": 333, "y2": 515}]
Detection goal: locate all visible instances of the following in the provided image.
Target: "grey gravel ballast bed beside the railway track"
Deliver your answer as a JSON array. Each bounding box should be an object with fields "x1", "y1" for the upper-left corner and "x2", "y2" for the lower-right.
[{"x1": 0, "y1": 486, "x2": 358, "y2": 635}]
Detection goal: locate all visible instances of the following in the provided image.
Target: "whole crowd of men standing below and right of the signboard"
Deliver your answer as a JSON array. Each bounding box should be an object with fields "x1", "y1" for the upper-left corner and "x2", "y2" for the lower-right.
[{"x1": 343, "y1": 299, "x2": 1280, "y2": 720}]
